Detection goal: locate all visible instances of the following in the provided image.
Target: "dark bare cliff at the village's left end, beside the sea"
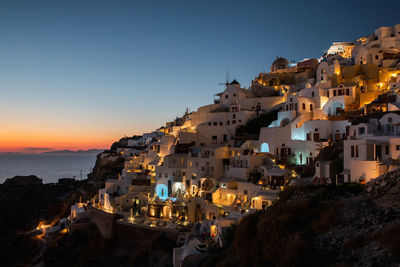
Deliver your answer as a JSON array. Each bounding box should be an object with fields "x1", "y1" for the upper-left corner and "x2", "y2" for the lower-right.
[{"x1": 88, "y1": 152, "x2": 124, "y2": 188}]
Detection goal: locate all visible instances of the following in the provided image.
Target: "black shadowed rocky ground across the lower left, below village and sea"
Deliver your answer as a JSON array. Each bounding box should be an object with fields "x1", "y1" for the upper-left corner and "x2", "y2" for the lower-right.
[{"x1": 0, "y1": 177, "x2": 176, "y2": 267}]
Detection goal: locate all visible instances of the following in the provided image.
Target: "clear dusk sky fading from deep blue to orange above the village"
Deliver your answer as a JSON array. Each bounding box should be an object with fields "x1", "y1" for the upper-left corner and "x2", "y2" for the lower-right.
[{"x1": 0, "y1": 0, "x2": 400, "y2": 152}]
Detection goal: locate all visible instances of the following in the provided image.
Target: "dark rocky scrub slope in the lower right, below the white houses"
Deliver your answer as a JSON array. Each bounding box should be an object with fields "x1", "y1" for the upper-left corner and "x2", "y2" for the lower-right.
[{"x1": 203, "y1": 170, "x2": 400, "y2": 266}]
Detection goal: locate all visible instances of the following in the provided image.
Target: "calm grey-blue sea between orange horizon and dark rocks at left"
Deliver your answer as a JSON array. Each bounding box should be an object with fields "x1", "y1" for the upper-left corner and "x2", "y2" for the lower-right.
[{"x1": 0, "y1": 154, "x2": 96, "y2": 183}]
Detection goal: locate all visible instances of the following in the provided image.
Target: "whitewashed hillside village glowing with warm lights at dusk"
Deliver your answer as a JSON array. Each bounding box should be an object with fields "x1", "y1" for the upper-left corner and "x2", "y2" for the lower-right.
[{"x1": 70, "y1": 24, "x2": 400, "y2": 266}]
